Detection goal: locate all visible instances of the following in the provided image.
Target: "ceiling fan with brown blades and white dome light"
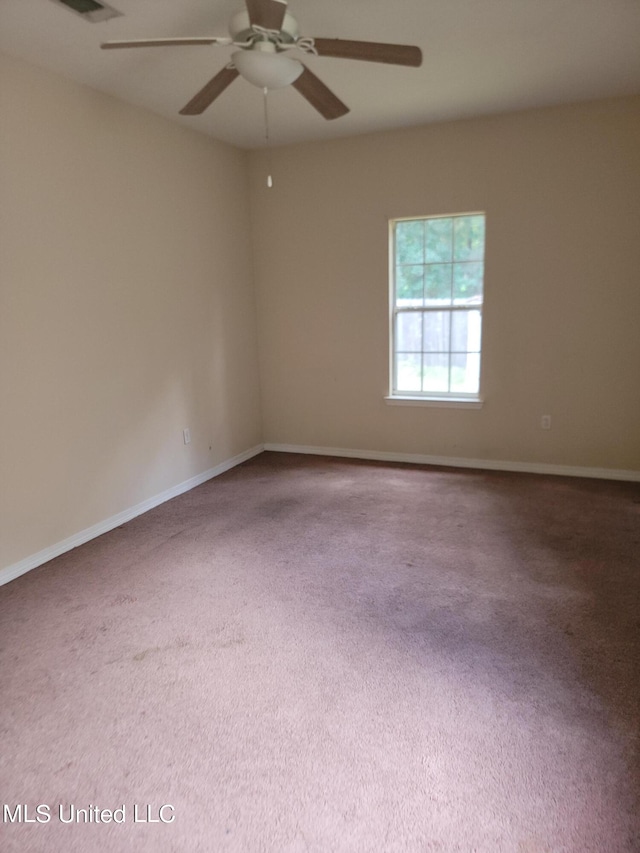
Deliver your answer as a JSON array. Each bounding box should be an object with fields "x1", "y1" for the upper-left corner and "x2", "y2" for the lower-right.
[{"x1": 101, "y1": 0, "x2": 422, "y2": 119}]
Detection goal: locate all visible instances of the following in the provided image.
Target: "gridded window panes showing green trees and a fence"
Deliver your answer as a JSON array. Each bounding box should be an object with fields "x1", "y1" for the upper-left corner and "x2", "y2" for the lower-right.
[{"x1": 391, "y1": 213, "x2": 485, "y2": 400}]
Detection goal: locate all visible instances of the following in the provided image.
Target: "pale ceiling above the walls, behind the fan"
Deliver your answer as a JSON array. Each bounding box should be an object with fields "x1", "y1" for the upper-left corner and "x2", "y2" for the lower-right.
[{"x1": 0, "y1": 0, "x2": 640, "y2": 148}]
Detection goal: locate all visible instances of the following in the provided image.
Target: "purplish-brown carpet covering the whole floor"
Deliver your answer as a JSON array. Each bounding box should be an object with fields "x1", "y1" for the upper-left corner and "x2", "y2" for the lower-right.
[{"x1": 0, "y1": 453, "x2": 640, "y2": 853}]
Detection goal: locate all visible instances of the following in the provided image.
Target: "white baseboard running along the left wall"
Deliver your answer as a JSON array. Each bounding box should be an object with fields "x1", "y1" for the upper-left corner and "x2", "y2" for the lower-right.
[{"x1": 0, "y1": 444, "x2": 264, "y2": 586}]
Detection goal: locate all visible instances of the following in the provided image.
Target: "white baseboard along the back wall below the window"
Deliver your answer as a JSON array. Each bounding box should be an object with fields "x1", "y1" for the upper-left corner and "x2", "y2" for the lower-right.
[{"x1": 264, "y1": 444, "x2": 640, "y2": 483}]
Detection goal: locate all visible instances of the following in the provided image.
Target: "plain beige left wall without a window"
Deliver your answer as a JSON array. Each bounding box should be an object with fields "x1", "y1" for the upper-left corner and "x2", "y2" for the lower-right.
[{"x1": 0, "y1": 57, "x2": 261, "y2": 568}]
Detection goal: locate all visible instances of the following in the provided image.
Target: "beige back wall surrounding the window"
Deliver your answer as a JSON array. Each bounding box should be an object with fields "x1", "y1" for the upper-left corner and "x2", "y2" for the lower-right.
[{"x1": 250, "y1": 97, "x2": 640, "y2": 471}]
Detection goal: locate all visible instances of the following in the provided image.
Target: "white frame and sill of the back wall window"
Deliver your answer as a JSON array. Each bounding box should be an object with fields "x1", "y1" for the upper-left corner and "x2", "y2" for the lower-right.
[{"x1": 385, "y1": 211, "x2": 486, "y2": 408}]
